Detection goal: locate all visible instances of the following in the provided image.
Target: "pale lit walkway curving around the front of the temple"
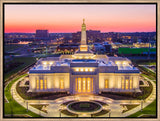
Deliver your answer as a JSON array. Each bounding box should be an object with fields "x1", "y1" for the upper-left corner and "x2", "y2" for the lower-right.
[{"x1": 11, "y1": 75, "x2": 156, "y2": 117}]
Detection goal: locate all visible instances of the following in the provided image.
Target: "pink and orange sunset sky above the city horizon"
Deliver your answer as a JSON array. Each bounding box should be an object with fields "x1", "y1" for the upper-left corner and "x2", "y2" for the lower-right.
[{"x1": 4, "y1": 4, "x2": 156, "y2": 33}]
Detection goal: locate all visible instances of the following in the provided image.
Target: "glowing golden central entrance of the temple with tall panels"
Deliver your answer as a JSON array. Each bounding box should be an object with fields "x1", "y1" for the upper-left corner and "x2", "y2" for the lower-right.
[{"x1": 75, "y1": 77, "x2": 93, "y2": 93}]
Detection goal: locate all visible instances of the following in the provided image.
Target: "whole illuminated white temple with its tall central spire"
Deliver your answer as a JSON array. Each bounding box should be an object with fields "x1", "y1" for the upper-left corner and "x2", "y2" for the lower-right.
[{"x1": 29, "y1": 20, "x2": 140, "y2": 94}]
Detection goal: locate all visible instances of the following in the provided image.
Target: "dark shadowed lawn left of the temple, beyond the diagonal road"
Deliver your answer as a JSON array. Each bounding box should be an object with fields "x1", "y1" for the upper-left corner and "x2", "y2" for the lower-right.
[{"x1": 4, "y1": 57, "x2": 36, "y2": 80}]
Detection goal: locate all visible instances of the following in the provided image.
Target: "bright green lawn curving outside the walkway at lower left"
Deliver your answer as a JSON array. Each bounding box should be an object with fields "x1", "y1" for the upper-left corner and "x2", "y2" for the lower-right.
[{"x1": 4, "y1": 74, "x2": 41, "y2": 117}]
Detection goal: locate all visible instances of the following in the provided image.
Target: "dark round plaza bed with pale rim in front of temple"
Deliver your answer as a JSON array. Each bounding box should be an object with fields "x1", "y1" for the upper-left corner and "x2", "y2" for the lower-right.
[{"x1": 67, "y1": 101, "x2": 102, "y2": 114}]
